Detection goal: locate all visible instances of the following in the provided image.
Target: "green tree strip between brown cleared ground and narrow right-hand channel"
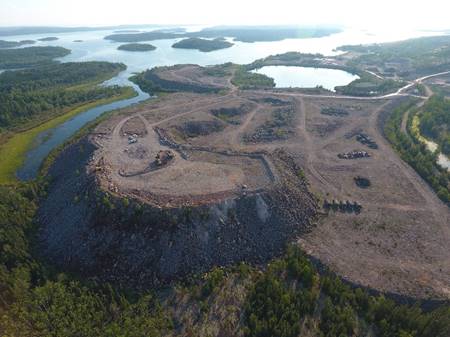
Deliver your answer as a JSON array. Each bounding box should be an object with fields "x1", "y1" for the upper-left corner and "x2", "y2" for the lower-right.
[{"x1": 384, "y1": 101, "x2": 450, "y2": 206}]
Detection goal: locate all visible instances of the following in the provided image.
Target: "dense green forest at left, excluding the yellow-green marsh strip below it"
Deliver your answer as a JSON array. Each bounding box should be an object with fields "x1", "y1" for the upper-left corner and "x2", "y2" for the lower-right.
[{"x1": 0, "y1": 62, "x2": 125, "y2": 130}]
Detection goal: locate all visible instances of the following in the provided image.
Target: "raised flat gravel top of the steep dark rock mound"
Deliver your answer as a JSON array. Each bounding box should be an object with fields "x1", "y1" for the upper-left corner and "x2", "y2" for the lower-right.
[{"x1": 91, "y1": 97, "x2": 276, "y2": 206}]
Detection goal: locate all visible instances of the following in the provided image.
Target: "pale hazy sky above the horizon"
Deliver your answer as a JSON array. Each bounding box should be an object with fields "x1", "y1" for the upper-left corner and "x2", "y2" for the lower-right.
[{"x1": 0, "y1": 0, "x2": 450, "y2": 30}]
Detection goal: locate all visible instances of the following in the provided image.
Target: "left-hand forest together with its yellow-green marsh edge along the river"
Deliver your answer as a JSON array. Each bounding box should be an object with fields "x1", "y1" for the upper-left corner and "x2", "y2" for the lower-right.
[{"x1": 0, "y1": 62, "x2": 134, "y2": 183}]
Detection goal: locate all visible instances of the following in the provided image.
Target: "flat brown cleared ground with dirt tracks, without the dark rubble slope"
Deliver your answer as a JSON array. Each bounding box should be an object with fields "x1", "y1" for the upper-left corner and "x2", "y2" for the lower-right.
[{"x1": 40, "y1": 59, "x2": 450, "y2": 298}]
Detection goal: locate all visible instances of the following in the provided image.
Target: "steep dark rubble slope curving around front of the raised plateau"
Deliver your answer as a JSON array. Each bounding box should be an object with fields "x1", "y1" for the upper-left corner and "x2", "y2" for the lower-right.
[{"x1": 39, "y1": 139, "x2": 316, "y2": 288}]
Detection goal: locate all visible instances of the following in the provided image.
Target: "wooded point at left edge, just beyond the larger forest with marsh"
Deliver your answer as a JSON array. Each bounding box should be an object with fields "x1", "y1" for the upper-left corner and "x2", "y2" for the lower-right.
[{"x1": 0, "y1": 47, "x2": 70, "y2": 69}]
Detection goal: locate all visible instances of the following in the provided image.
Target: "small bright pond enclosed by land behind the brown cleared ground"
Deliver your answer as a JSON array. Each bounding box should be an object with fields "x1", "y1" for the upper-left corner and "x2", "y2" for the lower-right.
[{"x1": 253, "y1": 66, "x2": 359, "y2": 91}]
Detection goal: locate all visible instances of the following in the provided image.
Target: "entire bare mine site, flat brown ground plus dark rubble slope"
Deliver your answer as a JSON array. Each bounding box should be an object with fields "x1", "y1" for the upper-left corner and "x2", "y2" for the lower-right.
[{"x1": 36, "y1": 59, "x2": 450, "y2": 298}]
